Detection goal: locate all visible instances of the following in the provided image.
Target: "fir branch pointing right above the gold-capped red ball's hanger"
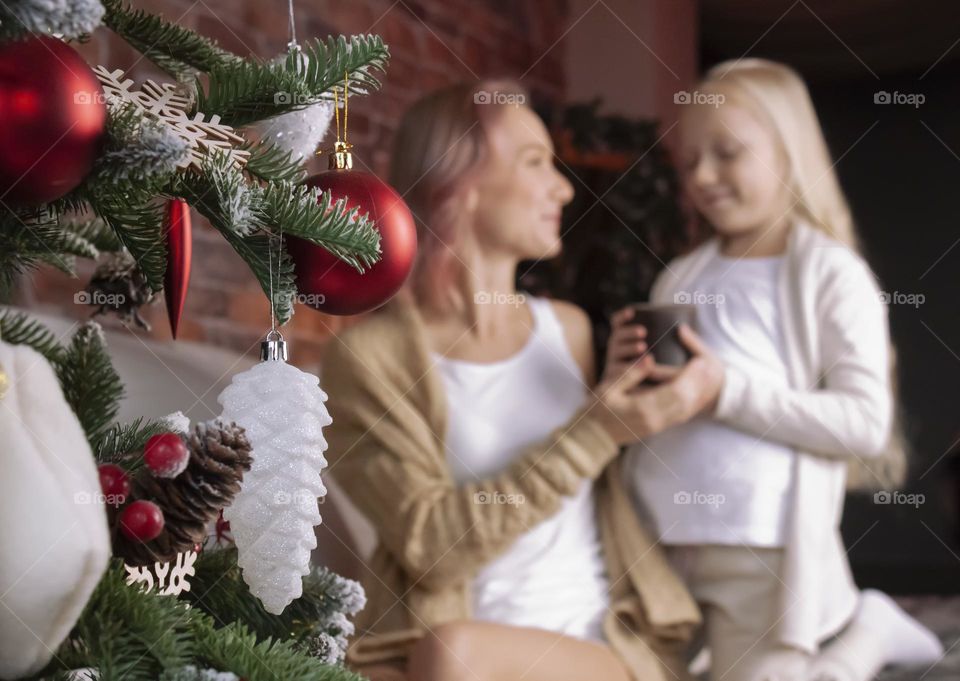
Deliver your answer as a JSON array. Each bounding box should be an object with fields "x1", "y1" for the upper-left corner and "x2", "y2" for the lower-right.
[{"x1": 194, "y1": 35, "x2": 390, "y2": 128}]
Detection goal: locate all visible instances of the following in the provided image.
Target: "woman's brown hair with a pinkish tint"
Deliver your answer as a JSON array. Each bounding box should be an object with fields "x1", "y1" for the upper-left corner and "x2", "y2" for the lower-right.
[{"x1": 390, "y1": 80, "x2": 528, "y2": 311}]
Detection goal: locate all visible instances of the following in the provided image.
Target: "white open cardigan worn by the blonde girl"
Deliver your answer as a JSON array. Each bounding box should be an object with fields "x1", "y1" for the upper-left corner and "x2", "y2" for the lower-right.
[{"x1": 651, "y1": 222, "x2": 893, "y2": 653}]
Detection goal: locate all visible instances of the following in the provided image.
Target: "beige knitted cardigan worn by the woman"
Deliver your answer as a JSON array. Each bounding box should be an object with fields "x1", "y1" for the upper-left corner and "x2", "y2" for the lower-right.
[{"x1": 323, "y1": 299, "x2": 700, "y2": 681}]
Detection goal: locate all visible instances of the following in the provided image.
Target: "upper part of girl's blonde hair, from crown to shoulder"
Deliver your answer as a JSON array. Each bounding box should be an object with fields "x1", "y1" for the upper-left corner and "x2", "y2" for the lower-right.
[{"x1": 701, "y1": 59, "x2": 858, "y2": 249}]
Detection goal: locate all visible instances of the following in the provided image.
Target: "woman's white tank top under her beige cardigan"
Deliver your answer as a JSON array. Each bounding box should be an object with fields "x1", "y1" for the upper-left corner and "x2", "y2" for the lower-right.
[{"x1": 433, "y1": 296, "x2": 609, "y2": 640}]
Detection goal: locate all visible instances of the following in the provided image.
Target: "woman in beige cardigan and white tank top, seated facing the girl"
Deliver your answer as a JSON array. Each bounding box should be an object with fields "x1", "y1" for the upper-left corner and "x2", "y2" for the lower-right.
[{"x1": 324, "y1": 82, "x2": 720, "y2": 681}]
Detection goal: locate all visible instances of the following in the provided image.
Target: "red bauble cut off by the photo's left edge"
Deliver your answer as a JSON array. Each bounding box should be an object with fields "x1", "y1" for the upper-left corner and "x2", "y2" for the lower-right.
[{"x1": 0, "y1": 36, "x2": 107, "y2": 204}]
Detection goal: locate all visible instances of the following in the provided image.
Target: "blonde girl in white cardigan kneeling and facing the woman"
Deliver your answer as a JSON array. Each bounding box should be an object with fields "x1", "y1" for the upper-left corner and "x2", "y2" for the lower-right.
[{"x1": 608, "y1": 59, "x2": 941, "y2": 681}]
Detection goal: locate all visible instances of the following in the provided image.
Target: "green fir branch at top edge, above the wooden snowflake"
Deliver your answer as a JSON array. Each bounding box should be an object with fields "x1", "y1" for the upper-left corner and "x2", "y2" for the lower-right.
[{"x1": 103, "y1": 0, "x2": 240, "y2": 81}]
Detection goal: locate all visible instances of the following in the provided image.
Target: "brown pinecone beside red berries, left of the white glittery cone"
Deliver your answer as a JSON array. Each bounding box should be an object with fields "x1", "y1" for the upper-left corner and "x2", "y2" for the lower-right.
[{"x1": 114, "y1": 419, "x2": 252, "y2": 565}]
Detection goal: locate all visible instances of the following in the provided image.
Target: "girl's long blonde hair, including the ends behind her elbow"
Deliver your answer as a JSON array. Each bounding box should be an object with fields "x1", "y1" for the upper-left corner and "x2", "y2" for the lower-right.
[{"x1": 700, "y1": 59, "x2": 908, "y2": 490}]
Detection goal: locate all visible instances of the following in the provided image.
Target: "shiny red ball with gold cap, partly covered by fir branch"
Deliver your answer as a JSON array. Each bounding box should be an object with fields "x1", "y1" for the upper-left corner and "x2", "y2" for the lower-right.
[{"x1": 287, "y1": 169, "x2": 417, "y2": 315}]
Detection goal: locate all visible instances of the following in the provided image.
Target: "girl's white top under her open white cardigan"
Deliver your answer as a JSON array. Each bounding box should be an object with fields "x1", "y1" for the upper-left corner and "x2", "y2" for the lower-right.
[{"x1": 626, "y1": 256, "x2": 796, "y2": 548}]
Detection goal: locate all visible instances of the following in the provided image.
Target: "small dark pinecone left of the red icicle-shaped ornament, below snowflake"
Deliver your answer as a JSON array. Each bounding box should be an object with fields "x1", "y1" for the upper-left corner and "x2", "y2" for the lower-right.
[{"x1": 85, "y1": 251, "x2": 154, "y2": 331}]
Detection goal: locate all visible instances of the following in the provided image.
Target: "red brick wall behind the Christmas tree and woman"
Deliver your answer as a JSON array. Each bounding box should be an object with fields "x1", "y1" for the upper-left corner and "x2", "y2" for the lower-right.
[{"x1": 15, "y1": 0, "x2": 567, "y2": 366}]
